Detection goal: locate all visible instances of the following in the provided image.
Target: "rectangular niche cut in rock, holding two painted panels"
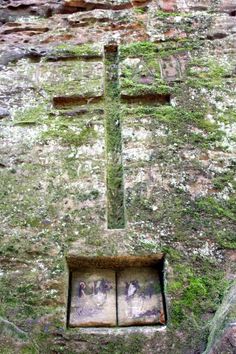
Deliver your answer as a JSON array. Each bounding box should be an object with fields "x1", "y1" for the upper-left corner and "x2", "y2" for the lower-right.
[{"x1": 67, "y1": 254, "x2": 166, "y2": 327}]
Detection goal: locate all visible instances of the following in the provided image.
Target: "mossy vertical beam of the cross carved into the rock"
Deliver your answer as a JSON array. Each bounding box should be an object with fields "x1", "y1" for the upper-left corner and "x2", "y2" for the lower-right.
[{"x1": 104, "y1": 44, "x2": 125, "y2": 229}]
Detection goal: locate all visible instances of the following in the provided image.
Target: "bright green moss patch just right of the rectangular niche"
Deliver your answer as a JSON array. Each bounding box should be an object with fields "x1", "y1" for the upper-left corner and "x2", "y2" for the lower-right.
[{"x1": 170, "y1": 259, "x2": 228, "y2": 326}]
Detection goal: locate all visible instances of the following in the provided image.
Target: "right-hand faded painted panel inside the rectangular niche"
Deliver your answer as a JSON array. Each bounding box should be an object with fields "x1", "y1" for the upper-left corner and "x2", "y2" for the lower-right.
[{"x1": 118, "y1": 268, "x2": 164, "y2": 326}]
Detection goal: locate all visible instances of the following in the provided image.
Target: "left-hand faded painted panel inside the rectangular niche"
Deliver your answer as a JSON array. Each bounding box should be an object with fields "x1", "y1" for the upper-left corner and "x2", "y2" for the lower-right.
[{"x1": 69, "y1": 270, "x2": 116, "y2": 327}]
